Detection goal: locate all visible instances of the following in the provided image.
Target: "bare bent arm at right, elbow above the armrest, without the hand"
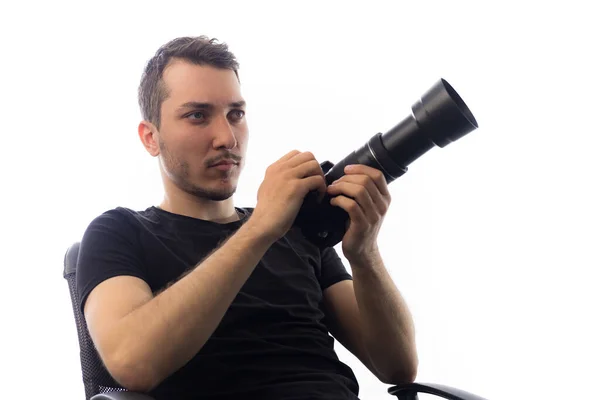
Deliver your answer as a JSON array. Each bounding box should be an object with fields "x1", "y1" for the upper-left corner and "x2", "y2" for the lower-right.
[{"x1": 324, "y1": 258, "x2": 418, "y2": 385}]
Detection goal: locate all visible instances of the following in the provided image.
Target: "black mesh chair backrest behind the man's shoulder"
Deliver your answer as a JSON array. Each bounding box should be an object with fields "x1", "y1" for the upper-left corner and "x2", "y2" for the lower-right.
[{"x1": 63, "y1": 242, "x2": 125, "y2": 400}]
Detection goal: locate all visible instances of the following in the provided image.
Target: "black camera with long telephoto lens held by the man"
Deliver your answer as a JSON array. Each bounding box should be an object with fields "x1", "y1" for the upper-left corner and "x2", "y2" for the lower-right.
[{"x1": 294, "y1": 79, "x2": 478, "y2": 248}]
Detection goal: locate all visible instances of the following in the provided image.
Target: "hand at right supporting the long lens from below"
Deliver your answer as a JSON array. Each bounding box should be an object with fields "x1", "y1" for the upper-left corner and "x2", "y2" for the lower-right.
[{"x1": 327, "y1": 164, "x2": 392, "y2": 264}]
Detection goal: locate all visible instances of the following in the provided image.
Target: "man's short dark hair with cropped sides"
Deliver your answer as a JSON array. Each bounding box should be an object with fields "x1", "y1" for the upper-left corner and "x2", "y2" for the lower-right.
[{"x1": 138, "y1": 36, "x2": 239, "y2": 127}]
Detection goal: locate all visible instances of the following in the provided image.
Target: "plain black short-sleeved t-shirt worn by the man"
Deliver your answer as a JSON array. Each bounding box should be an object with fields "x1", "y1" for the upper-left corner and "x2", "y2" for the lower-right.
[{"x1": 77, "y1": 207, "x2": 358, "y2": 400}]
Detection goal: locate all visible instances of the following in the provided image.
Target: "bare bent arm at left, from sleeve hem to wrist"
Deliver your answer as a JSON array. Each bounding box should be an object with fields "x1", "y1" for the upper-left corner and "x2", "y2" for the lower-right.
[{"x1": 84, "y1": 218, "x2": 273, "y2": 391}]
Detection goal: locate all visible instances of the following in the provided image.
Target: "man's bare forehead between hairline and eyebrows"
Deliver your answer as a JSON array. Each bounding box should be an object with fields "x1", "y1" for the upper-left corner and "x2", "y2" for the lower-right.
[{"x1": 163, "y1": 60, "x2": 242, "y2": 105}]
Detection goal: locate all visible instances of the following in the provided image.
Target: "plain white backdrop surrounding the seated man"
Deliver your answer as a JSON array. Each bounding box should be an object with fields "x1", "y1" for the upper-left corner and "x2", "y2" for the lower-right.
[{"x1": 0, "y1": 0, "x2": 600, "y2": 399}]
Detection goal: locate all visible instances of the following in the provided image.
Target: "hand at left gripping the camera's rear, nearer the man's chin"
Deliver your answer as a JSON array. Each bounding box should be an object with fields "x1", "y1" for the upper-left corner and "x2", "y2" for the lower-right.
[{"x1": 252, "y1": 150, "x2": 327, "y2": 239}]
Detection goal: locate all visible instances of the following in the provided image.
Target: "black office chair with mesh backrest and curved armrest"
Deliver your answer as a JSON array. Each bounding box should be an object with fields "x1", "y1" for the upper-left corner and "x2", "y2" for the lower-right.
[{"x1": 63, "y1": 242, "x2": 485, "y2": 400}]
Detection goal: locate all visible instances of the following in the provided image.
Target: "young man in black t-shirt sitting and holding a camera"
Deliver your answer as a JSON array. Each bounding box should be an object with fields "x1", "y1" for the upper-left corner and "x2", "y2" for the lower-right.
[{"x1": 77, "y1": 37, "x2": 417, "y2": 399}]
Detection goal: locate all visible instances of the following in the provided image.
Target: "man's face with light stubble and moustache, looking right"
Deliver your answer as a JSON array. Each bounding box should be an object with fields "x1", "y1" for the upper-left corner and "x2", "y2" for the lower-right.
[{"x1": 158, "y1": 60, "x2": 248, "y2": 201}]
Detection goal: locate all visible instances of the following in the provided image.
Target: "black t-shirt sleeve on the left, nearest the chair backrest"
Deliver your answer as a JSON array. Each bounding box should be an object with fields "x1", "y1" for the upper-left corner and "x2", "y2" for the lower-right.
[{"x1": 76, "y1": 210, "x2": 147, "y2": 313}]
